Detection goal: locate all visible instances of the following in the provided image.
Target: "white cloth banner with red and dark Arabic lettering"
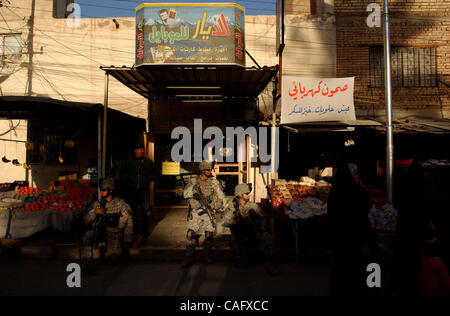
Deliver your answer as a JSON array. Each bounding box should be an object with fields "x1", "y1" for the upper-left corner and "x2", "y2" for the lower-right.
[{"x1": 281, "y1": 76, "x2": 356, "y2": 124}]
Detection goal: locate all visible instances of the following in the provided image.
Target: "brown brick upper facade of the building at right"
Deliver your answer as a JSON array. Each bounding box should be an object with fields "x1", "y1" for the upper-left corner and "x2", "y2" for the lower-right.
[{"x1": 334, "y1": 0, "x2": 450, "y2": 119}]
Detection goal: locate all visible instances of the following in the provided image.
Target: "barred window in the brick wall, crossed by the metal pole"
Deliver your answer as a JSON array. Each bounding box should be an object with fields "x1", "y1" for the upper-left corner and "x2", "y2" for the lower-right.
[{"x1": 370, "y1": 46, "x2": 436, "y2": 87}]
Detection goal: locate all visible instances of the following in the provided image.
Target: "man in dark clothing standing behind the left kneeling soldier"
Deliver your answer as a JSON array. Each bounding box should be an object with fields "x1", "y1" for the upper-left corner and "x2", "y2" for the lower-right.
[{"x1": 120, "y1": 144, "x2": 160, "y2": 245}]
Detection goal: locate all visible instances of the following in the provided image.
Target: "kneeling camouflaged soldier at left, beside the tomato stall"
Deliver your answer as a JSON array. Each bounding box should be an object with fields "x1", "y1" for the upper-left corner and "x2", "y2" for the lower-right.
[{"x1": 81, "y1": 179, "x2": 133, "y2": 263}]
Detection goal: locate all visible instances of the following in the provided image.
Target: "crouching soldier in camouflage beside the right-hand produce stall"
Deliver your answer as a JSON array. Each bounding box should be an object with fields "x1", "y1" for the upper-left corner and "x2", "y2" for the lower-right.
[{"x1": 223, "y1": 183, "x2": 278, "y2": 275}]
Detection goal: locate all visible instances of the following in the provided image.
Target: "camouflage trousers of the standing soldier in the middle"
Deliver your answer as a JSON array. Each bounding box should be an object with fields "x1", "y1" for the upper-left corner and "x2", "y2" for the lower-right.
[{"x1": 186, "y1": 209, "x2": 214, "y2": 257}]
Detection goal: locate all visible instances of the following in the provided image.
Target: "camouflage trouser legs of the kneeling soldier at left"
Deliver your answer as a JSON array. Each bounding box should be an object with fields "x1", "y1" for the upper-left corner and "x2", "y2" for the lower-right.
[{"x1": 81, "y1": 230, "x2": 123, "y2": 260}]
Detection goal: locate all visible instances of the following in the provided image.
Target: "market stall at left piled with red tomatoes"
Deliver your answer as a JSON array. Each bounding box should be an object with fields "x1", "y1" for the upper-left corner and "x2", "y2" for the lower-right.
[{"x1": 0, "y1": 180, "x2": 97, "y2": 239}]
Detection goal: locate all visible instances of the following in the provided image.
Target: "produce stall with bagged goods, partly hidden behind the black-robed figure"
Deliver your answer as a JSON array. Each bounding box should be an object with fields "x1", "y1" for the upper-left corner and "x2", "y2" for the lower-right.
[{"x1": 269, "y1": 177, "x2": 398, "y2": 260}]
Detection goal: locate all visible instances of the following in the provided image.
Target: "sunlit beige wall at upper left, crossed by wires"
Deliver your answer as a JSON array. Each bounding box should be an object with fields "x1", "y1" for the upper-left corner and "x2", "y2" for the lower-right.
[{"x1": 0, "y1": 0, "x2": 147, "y2": 118}]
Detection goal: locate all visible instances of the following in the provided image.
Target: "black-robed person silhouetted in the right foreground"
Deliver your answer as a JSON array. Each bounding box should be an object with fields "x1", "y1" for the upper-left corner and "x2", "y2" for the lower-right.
[{"x1": 328, "y1": 164, "x2": 374, "y2": 296}]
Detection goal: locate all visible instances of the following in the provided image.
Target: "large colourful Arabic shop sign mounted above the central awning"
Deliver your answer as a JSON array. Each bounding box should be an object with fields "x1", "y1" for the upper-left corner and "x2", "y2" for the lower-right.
[{"x1": 136, "y1": 3, "x2": 245, "y2": 66}]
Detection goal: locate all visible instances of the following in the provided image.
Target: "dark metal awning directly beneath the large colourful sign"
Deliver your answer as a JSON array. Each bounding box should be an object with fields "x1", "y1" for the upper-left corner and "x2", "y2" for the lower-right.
[{"x1": 101, "y1": 65, "x2": 278, "y2": 101}]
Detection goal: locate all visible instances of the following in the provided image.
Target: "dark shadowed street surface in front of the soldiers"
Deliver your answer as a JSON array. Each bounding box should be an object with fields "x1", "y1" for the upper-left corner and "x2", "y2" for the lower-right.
[{"x1": 0, "y1": 259, "x2": 330, "y2": 296}]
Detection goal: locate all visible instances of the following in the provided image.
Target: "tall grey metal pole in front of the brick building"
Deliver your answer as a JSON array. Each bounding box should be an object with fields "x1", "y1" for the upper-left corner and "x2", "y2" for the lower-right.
[{"x1": 383, "y1": 0, "x2": 394, "y2": 203}]
